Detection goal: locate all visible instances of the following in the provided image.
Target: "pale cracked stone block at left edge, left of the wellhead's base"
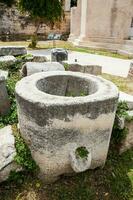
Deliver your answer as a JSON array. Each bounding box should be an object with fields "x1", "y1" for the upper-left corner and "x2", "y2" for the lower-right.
[{"x1": 0, "y1": 126, "x2": 18, "y2": 182}]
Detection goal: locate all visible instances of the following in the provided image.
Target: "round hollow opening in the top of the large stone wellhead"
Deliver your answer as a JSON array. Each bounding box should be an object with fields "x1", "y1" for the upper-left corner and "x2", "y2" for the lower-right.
[{"x1": 37, "y1": 75, "x2": 97, "y2": 97}]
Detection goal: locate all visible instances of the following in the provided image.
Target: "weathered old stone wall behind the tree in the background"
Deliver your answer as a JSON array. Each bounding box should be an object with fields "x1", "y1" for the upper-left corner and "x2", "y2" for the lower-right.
[{"x1": 0, "y1": 3, "x2": 70, "y2": 40}]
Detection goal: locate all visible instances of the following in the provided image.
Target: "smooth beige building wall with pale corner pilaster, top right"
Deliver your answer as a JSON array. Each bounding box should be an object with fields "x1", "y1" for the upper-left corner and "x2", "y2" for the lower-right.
[{"x1": 70, "y1": 0, "x2": 133, "y2": 45}]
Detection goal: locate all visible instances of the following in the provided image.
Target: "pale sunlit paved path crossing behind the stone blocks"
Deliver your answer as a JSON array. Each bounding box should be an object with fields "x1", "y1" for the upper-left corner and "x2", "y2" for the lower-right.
[{"x1": 29, "y1": 50, "x2": 131, "y2": 77}]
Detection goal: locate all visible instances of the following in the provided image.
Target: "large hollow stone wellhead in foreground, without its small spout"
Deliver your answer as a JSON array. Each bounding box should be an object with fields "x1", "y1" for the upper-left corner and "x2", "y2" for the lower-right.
[{"x1": 16, "y1": 71, "x2": 118, "y2": 181}]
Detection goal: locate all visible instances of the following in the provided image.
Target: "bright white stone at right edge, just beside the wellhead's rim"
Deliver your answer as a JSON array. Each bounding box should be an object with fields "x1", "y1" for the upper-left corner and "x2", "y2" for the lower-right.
[{"x1": 119, "y1": 92, "x2": 133, "y2": 110}]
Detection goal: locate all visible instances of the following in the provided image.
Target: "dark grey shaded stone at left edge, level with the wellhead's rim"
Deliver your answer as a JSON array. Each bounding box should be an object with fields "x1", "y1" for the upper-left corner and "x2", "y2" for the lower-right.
[{"x1": 0, "y1": 76, "x2": 10, "y2": 115}]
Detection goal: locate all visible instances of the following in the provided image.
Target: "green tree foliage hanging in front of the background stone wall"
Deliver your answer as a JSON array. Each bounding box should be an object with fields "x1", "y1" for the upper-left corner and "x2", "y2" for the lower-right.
[{"x1": 19, "y1": 0, "x2": 63, "y2": 24}]
